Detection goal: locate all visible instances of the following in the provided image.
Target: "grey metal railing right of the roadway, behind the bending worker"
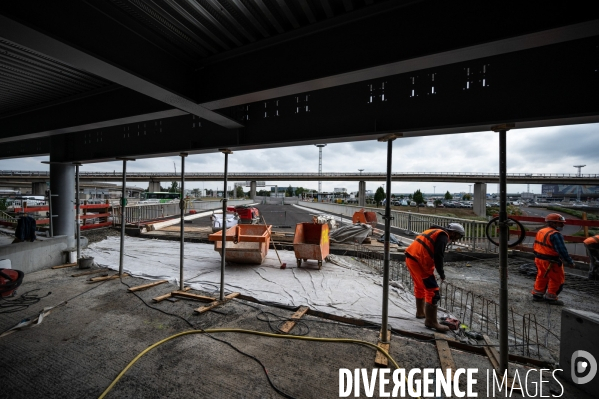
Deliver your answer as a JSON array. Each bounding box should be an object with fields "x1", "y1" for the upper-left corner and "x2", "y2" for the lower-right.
[{"x1": 300, "y1": 202, "x2": 498, "y2": 253}]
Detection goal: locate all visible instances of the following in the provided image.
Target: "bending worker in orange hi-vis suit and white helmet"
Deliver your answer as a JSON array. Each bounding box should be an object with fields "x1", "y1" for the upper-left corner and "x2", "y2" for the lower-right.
[{"x1": 406, "y1": 223, "x2": 464, "y2": 332}]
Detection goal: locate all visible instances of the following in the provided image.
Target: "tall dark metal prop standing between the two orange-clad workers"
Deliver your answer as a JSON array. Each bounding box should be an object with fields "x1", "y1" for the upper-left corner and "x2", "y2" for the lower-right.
[{"x1": 499, "y1": 128, "x2": 509, "y2": 375}]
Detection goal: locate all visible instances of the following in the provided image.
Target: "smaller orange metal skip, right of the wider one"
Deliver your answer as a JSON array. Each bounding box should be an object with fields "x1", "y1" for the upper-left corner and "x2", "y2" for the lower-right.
[{"x1": 293, "y1": 223, "x2": 329, "y2": 269}]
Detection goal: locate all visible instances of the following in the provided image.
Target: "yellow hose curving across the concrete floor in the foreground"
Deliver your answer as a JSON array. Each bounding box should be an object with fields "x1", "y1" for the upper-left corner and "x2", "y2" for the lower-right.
[{"x1": 99, "y1": 328, "x2": 410, "y2": 399}]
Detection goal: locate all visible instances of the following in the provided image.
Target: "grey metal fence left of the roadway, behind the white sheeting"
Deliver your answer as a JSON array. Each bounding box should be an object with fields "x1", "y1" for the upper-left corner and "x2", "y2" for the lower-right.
[{"x1": 112, "y1": 200, "x2": 253, "y2": 225}]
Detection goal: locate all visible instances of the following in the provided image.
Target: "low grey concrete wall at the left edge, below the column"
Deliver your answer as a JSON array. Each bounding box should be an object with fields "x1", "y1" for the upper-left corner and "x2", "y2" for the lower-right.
[{"x1": 0, "y1": 236, "x2": 72, "y2": 274}]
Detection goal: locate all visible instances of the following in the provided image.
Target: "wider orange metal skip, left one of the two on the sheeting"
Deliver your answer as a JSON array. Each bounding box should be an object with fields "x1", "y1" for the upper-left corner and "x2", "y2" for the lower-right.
[{"x1": 208, "y1": 224, "x2": 272, "y2": 265}]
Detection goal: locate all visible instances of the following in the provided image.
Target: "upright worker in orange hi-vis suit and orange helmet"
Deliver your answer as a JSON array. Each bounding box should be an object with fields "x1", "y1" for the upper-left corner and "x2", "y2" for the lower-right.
[{"x1": 531, "y1": 213, "x2": 574, "y2": 306}]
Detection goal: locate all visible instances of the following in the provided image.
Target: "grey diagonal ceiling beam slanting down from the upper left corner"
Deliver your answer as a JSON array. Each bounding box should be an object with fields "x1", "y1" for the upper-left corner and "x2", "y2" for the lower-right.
[{"x1": 0, "y1": 7, "x2": 242, "y2": 128}]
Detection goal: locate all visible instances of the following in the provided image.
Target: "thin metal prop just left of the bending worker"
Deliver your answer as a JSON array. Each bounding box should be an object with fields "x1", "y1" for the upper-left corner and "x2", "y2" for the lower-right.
[{"x1": 378, "y1": 135, "x2": 395, "y2": 342}]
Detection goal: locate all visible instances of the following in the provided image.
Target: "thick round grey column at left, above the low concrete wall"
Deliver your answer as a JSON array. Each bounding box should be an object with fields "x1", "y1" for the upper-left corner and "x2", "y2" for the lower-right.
[{"x1": 50, "y1": 164, "x2": 75, "y2": 238}]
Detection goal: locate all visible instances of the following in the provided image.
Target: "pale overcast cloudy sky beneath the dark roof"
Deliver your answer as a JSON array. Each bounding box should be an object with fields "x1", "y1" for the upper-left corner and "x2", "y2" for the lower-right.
[{"x1": 0, "y1": 124, "x2": 599, "y2": 193}]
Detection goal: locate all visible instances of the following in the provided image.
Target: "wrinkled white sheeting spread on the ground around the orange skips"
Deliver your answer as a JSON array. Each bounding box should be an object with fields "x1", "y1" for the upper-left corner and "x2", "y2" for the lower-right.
[{"x1": 83, "y1": 237, "x2": 424, "y2": 331}]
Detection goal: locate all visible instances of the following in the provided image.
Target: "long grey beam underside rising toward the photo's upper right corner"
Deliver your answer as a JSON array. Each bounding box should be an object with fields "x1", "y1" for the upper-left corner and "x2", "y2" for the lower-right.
[{"x1": 201, "y1": 20, "x2": 599, "y2": 109}]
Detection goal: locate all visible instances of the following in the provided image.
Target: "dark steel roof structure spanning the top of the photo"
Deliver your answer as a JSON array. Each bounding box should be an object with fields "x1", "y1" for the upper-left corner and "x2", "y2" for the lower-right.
[{"x1": 0, "y1": 0, "x2": 599, "y2": 162}]
